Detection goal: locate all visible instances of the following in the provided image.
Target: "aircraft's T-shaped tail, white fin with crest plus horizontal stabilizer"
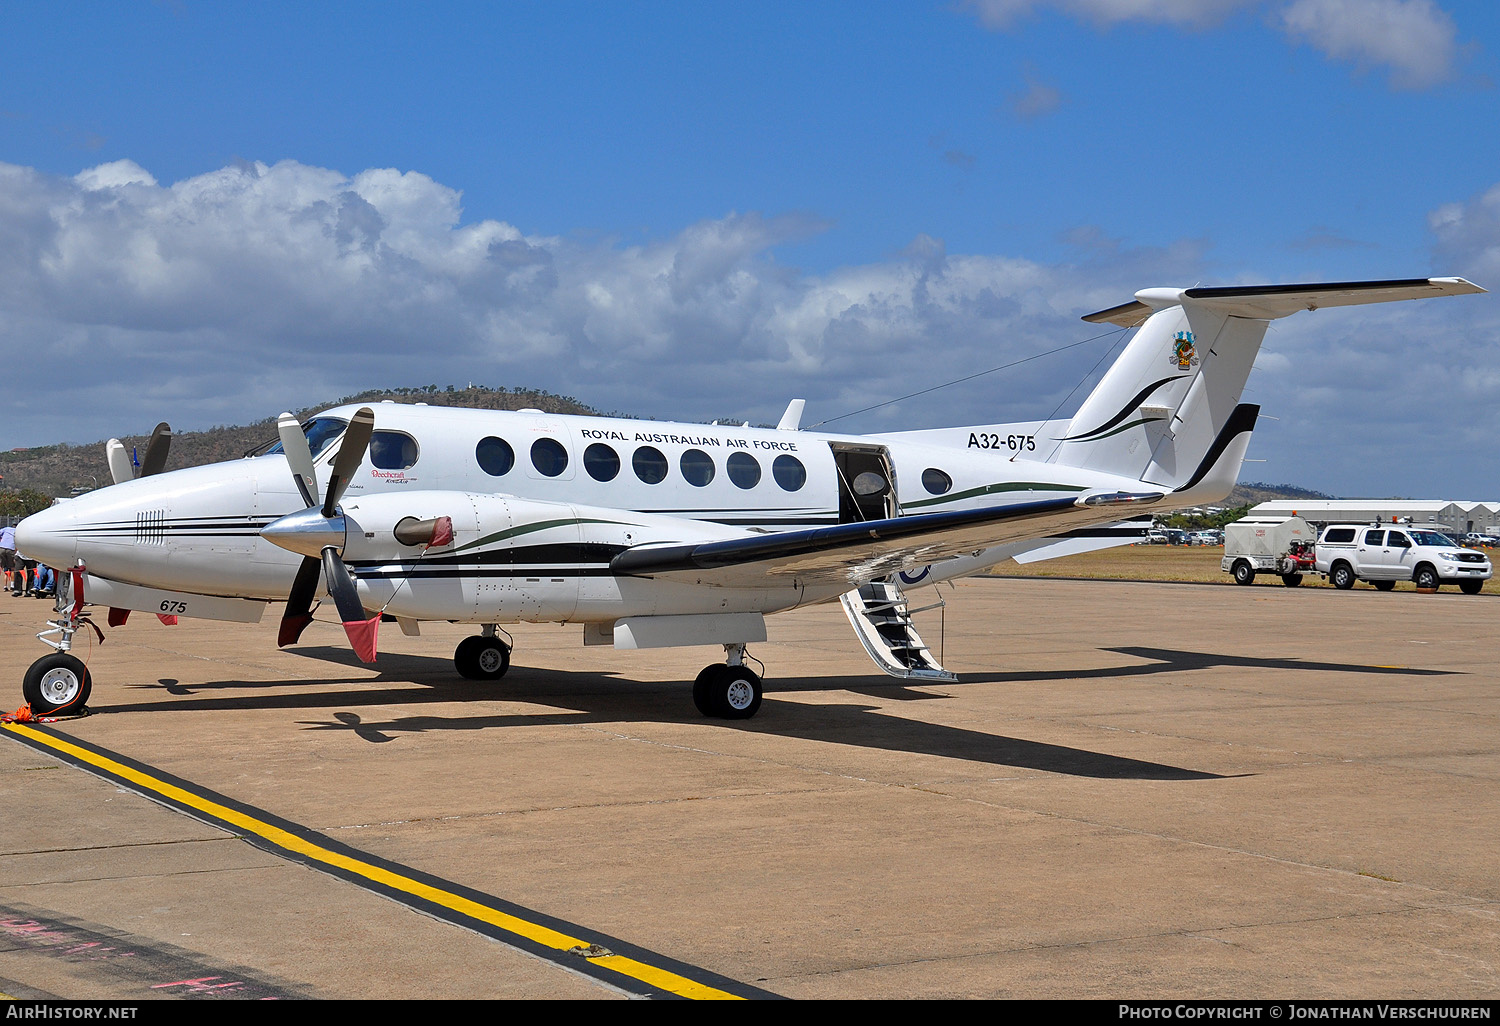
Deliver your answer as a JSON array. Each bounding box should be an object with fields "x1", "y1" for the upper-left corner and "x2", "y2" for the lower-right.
[{"x1": 1053, "y1": 278, "x2": 1485, "y2": 501}]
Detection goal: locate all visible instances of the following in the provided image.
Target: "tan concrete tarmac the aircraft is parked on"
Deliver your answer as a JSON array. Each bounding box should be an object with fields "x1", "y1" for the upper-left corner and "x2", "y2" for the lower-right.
[{"x1": 0, "y1": 579, "x2": 1500, "y2": 1001}]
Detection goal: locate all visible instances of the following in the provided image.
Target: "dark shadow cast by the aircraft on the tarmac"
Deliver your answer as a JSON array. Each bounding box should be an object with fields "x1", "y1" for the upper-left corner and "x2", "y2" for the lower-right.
[{"x1": 93, "y1": 647, "x2": 1449, "y2": 780}]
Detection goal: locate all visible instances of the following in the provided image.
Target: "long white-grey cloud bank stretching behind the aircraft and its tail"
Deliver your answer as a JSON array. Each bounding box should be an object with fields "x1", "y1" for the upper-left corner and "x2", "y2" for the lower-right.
[{"x1": 0, "y1": 161, "x2": 1500, "y2": 498}]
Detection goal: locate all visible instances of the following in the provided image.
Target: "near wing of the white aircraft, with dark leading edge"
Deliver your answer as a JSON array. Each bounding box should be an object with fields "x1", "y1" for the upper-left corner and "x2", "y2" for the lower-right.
[{"x1": 609, "y1": 492, "x2": 1164, "y2": 587}]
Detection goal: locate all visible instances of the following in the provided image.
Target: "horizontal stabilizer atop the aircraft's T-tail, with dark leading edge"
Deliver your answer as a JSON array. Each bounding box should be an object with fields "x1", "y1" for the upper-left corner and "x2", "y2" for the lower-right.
[{"x1": 1083, "y1": 278, "x2": 1485, "y2": 327}]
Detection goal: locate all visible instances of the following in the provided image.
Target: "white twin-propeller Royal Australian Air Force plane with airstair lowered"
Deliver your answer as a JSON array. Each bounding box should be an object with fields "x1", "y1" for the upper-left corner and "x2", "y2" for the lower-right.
[{"x1": 17, "y1": 278, "x2": 1484, "y2": 719}]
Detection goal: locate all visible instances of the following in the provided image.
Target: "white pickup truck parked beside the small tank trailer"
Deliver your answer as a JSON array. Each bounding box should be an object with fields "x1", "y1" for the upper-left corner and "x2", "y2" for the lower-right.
[{"x1": 1314, "y1": 524, "x2": 1494, "y2": 596}]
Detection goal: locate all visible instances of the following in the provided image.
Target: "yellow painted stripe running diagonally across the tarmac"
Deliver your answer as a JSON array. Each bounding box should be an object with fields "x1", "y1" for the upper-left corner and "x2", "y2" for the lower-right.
[{"x1": 0, "y1": 723, "x2": 770, "y2": 1001}]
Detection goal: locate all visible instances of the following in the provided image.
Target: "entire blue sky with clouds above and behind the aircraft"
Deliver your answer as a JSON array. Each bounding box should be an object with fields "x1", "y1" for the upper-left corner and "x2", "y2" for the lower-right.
[{"x1": 0, "y1": 0, "x2": 1500, "y2": 500}]
